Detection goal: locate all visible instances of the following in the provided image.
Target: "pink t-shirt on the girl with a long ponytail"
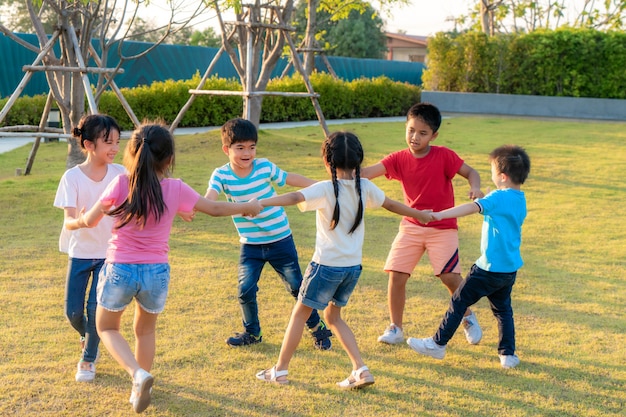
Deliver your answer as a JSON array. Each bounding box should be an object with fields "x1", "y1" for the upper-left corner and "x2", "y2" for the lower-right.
[{"x1": 100, "y1": 175, "x2": 200, "y2": 264}]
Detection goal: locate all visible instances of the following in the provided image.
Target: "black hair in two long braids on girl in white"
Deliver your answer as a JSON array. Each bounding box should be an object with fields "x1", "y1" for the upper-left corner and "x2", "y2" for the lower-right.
[{"x1": 322, "y1": 132, "x2": 363, "y2": 233}]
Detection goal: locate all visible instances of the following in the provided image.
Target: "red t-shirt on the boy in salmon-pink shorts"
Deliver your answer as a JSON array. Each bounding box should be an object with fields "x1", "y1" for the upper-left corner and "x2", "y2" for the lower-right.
[{"x1": 381, "y1": 146, "x2": 463, "y2": 229}]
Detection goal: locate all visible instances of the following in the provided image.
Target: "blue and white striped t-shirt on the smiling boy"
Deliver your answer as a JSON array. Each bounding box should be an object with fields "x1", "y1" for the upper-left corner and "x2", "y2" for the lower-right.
[{"x1": 209, "y1": 158, "x2": 291, "y2": 245}]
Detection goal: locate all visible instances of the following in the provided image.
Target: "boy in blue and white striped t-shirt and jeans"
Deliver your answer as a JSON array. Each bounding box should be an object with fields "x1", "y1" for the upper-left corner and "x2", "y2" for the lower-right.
[{"x1": 205, "y1": 119, "x2": 332, "y2": 350}]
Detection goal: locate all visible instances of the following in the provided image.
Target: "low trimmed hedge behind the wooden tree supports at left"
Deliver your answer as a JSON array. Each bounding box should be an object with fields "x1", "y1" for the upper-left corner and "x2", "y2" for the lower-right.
[{"x1": 0, "y1": 73, "x2": 421, "y2": 130}]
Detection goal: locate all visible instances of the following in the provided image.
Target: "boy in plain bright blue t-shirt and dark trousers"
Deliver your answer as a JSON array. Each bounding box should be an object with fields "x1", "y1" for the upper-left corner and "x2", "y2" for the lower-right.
[{"x1": 407, "y1": 145, "x2": 530, "y2": 369}]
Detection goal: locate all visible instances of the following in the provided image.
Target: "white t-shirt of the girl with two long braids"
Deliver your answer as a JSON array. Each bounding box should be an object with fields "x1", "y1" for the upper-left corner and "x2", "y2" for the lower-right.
[{"x1": 298, "y1": 178, "x2": 385, "y2": 267}]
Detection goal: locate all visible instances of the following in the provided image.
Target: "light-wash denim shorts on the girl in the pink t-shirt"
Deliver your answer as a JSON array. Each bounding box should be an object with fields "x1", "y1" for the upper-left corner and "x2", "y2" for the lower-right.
[{"x1": 98, "y1": 263, "x2": 170, "y2": 314}]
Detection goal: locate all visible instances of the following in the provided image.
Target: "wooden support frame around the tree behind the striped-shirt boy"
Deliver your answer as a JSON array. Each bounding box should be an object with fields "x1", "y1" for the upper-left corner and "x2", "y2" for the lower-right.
[{"x1": 170, "y1": 5, "x2": 330, "y2": 136}]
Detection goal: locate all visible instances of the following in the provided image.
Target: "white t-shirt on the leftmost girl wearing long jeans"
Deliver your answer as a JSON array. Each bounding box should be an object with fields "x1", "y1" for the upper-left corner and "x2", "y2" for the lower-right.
[{"x1": 54, "y1": 164, "x2": 126, "y2": 259}]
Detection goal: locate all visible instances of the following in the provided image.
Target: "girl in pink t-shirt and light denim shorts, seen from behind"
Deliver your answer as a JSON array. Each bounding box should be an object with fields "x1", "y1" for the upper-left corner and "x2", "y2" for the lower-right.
[{"x1": 77, "y1": 124, "x2": 262, "y2": 413}]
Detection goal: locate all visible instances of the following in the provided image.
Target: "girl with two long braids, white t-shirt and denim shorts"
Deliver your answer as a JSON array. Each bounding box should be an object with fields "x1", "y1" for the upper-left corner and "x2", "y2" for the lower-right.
[{"x1": 256, "y1": 132, "x2": 430, "y2": 389}]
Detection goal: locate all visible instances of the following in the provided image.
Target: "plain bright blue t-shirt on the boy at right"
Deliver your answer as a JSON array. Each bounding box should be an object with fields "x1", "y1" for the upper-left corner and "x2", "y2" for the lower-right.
[{"x1": 476, "y1": 188, "x2": 526, "y2": 273}]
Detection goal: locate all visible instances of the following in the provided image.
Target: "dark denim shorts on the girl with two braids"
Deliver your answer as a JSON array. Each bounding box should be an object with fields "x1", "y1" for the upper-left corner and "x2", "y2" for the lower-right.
[{"x1": 298, "y1": 262, "x2": 362, "y2": 310}]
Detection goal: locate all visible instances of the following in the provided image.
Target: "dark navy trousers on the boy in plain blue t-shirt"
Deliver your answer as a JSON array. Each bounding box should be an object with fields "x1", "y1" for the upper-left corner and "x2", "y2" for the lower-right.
[{"x1": 433, "y1": 265, "x2": 517, "y2": 355}]
